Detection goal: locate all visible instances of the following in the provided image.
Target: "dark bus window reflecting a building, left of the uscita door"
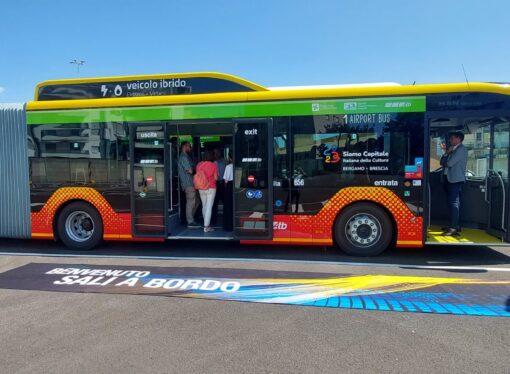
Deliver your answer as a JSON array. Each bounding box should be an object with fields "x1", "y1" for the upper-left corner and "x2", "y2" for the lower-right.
[{"x1": 28, "y1": 122, "x2": 129, "y2": 185}]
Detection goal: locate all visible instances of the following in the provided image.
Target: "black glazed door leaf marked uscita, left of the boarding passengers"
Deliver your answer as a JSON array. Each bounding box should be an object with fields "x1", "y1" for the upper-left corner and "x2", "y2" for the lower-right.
[{"x1": 130, "y1": 124, "x2": 167, "y2": 237}]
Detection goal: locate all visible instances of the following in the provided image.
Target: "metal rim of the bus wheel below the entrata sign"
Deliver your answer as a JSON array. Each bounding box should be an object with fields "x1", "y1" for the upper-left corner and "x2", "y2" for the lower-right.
[{"x1": 345, "y1": 213, "x2": 382, "y2": 248}]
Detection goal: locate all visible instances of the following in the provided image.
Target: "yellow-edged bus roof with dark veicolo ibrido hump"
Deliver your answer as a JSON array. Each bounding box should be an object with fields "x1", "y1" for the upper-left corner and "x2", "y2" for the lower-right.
[{"x1": 27, "y1": 72, "x2": 510, "y2": 110}]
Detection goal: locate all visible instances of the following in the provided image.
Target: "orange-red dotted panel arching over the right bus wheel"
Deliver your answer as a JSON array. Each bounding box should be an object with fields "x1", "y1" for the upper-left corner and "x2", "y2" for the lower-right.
[{"x1": 274, "y1": 187, "x2": 423, "y2": 246}]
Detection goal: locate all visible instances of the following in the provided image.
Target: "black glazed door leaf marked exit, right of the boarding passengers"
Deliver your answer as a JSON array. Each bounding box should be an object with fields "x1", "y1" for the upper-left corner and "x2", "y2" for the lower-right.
[{"x1": 234, "y1": 119, "x2": 273, "y2": 240}]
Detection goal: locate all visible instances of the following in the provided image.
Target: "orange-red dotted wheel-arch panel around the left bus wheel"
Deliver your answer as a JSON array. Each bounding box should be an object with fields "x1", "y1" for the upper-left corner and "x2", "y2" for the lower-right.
[{"x1": 31, "y1": 187, "x2": 131, "y2": 239}]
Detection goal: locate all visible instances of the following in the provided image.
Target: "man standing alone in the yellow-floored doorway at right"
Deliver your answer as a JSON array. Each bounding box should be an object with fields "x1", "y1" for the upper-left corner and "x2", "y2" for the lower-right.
[{"x1": 440, "y1": 131, "x2": 468, "y2": 236}]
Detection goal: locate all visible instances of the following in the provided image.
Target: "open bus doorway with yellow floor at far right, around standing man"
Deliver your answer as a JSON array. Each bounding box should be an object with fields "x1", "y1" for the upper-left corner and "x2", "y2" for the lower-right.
[{"x1": 427, "y1": 116, "x2": 510, "y2": 245}]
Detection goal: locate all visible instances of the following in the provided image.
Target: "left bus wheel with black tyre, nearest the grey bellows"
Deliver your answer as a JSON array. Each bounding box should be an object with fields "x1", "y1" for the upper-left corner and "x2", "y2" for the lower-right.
[{"x1": 57, "y1": 201, "x2": 103, "y2": 250}]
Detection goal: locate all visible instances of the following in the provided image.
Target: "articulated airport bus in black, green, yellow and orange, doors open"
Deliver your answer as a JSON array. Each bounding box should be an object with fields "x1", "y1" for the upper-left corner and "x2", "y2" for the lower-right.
[{"x1": 0, "y1": 73, "x2": 510, "y2": 256}]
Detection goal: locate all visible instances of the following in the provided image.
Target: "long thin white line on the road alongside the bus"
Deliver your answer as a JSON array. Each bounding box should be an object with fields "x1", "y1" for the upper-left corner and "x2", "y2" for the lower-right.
[{"x1": 0, "y1": 252, "x2": 510, "y2": 272}]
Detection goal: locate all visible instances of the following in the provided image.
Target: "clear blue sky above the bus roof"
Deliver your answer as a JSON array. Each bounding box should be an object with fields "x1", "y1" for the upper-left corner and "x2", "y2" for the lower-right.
[{"x1": 0, "y1": 0, "x2": 510, "y2": 102}]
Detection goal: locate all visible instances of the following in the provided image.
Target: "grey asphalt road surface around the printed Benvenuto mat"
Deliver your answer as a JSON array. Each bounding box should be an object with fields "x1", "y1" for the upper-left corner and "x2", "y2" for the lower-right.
[{"x1": 0, "y1": 240, "x2": 510, "y2": 373}]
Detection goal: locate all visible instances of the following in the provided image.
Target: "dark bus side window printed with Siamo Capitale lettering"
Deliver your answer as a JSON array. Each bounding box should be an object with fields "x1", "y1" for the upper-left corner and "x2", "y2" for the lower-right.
[{"x1": 290, "y1": 113, "x2": 424, "y2": 214}]
